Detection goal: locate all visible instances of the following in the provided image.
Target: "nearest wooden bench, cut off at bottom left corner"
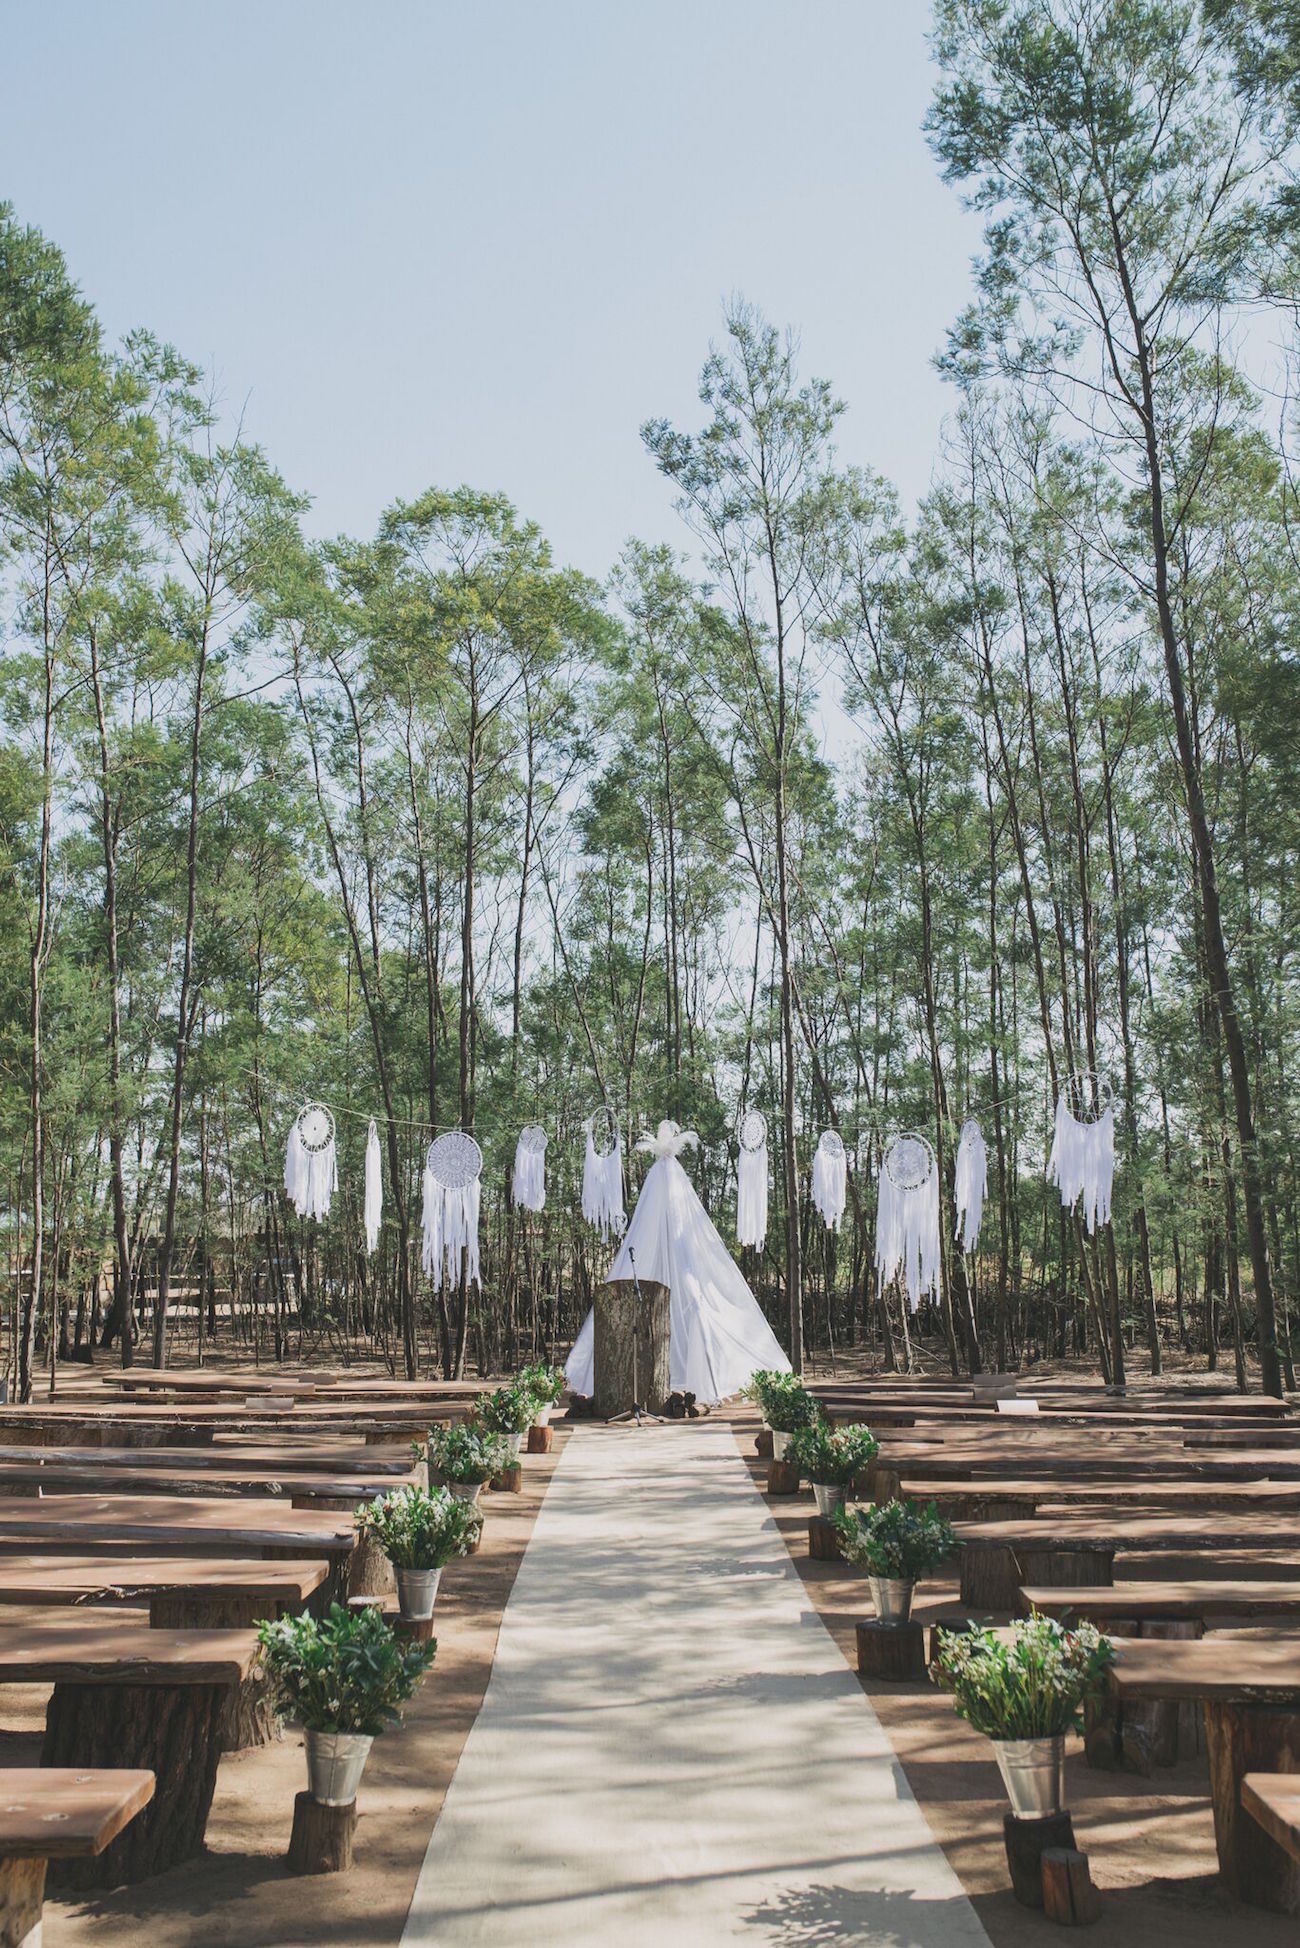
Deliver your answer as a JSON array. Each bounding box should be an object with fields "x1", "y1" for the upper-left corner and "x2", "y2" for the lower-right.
[{"x1": 0, "y1": 1765, "x2": 154, "y2": 1948}]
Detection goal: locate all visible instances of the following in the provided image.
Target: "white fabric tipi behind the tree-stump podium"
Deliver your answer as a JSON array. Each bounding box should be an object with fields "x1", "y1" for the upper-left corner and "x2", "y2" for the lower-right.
[{"x1": 565, "y1": 1122, "x2": 789, "y2": 1405}]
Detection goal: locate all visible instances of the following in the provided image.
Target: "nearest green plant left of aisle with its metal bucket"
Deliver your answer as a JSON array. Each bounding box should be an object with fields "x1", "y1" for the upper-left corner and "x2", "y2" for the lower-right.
[{"x1": 257, "y1": 1603, "x2": 439, "y2": 1806}]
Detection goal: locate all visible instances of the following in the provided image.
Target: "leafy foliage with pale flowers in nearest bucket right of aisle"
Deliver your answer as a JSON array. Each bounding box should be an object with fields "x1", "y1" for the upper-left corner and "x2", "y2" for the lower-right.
[{"x1": 936, "y1": 1613, "x2": 1115, "y2": 1738}]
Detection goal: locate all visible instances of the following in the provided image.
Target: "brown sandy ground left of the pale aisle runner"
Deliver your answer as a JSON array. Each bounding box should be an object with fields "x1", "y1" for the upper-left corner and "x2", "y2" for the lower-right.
[{"x1": 0, "y1": 1428, "x2": 567, "y2": 1948}]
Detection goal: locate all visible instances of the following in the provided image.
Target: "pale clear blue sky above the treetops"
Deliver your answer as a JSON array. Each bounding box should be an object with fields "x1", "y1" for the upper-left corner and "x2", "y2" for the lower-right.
[{"x1": 0, "y1": 0, "x2": 978, "y2": 575}]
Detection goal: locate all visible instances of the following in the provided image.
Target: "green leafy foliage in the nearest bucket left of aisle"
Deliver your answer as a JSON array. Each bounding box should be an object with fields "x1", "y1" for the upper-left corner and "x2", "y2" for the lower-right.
[{"x1": 257, "y1": 1603, "x2": 439, "y2": 1738}]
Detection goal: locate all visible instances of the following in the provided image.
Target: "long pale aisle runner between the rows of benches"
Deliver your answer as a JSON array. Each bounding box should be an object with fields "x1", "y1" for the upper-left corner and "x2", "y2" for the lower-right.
[{"x1": 403, "y1": 1420, "x2": 988, "y2": 1948}]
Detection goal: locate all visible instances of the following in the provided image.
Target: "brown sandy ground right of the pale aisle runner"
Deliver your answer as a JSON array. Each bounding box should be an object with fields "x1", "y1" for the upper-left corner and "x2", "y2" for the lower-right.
[{"x1": 735, "y1": 1414, "x2": 1296, "y2": 1948}]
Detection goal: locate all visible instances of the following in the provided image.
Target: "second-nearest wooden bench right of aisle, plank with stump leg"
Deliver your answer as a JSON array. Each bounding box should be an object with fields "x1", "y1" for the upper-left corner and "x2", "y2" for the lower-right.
[{"x1": 1109, "y1": 1634, "x2": 1300, "y2": 1915}]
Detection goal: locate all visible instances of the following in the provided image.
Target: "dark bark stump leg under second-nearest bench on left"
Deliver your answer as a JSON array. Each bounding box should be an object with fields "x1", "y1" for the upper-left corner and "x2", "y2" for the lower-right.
[{"x1": 41, "y1": 1685, "x2": 232, "y2": 1893}]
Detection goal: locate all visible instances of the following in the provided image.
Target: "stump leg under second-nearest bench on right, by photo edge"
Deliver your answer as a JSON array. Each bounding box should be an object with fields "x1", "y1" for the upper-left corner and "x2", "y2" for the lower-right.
[{"x1": 1204, "y1": 1701, "x2": 1300, "y2": 1915}]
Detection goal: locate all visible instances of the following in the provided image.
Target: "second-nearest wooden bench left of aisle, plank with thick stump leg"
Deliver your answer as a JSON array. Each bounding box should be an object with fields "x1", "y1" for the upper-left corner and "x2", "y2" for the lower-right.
[{"x1": 0, "y1": 1617, "x2": 257, "y2": 1890}]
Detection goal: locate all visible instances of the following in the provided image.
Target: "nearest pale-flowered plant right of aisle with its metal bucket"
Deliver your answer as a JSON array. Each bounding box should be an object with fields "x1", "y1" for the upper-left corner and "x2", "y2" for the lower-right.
[{"x1": 936, "y1": 1613, "x2": 1115, "y2": 1819}]
